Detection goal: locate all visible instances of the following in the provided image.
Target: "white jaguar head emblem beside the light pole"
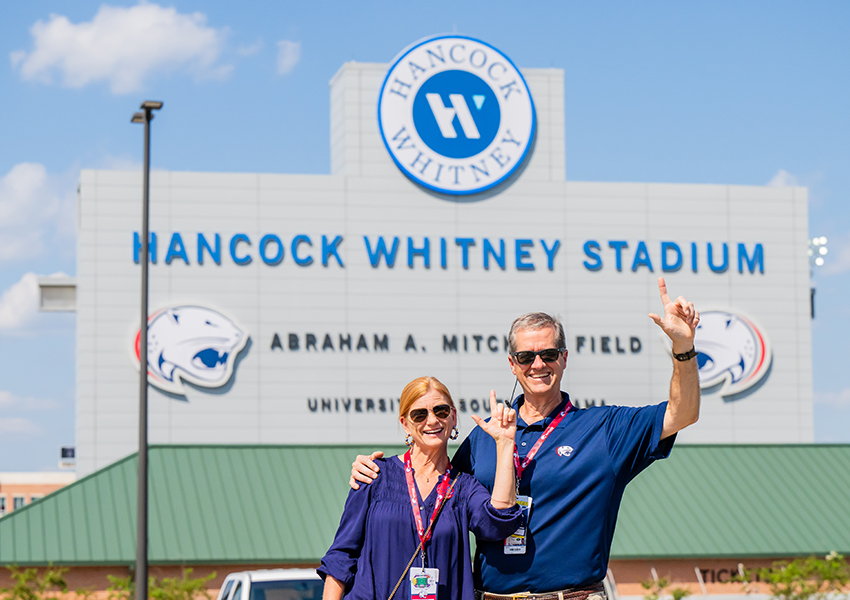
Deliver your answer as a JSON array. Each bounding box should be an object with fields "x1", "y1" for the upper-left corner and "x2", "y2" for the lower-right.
[{"x1": 134, "y1": 306, "x2": 248, "y2": 394}]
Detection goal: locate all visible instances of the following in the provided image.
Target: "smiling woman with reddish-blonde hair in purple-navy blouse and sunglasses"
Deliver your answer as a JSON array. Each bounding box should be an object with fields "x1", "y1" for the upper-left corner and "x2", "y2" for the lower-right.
[{"x1": 318, "y1": 377, "x2": 522, "y2": 600}]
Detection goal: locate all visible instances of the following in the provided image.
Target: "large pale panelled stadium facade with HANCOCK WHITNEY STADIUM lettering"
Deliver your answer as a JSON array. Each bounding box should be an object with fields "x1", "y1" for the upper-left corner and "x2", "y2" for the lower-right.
[{"x1": 43, "y1": 36, "x2": 813, "y2": 476}]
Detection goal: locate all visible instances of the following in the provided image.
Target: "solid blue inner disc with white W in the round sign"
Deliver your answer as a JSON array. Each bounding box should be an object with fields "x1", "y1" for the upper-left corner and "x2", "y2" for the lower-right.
[{"x1": 413, "y1": 71, "x2": 501, "y2": 158}]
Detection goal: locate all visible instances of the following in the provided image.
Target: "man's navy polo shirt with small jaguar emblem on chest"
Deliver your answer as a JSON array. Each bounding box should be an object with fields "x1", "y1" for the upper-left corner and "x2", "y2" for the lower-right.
[{"x1": 452, "y1": 392, "x2": 676, "y2": 593}]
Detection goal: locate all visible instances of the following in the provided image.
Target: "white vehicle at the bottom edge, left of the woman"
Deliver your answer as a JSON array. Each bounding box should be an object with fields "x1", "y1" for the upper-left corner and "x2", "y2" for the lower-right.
[{"x1": 216, "y1": 569, "x2": 325, "y2": 600}]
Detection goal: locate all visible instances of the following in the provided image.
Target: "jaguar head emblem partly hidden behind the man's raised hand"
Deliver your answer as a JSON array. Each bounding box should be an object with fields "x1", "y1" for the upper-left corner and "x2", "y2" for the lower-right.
[{"x1": 694, "y1": 310, "x2": 772, "y2": 400}]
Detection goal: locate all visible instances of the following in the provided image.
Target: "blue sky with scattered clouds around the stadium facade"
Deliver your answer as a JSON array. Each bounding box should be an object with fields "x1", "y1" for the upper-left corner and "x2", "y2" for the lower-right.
[{"x1": 0, "y1": 0, "x2": 850, "y2": 471}]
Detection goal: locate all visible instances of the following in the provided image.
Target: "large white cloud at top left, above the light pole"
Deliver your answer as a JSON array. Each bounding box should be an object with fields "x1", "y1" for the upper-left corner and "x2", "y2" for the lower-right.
[{"x1": 10, "y1": 1, "x2": 232, "y2": 94}]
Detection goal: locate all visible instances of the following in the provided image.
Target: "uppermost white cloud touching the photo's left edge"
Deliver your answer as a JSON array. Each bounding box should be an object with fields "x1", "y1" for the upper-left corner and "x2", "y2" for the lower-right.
[{"x1": 0, "y1": 163, "x2": 76, "y2": 264}]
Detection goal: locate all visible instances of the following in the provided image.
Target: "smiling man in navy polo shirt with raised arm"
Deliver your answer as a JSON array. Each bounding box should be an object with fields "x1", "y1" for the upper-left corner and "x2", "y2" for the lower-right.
[{"x1": 351, "y1": 278, "x2": 699, "y2": 600}]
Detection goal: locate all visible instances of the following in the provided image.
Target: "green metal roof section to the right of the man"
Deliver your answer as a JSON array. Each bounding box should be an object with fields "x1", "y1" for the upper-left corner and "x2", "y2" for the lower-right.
[{"x1": 612, "y1": 444, "x2": 850, "y2": 559}]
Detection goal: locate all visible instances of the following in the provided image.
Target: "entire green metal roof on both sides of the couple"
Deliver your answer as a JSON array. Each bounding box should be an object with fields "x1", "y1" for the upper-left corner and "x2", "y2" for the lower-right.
[{"x1": 0, "y1": 445, "x2": 850, "y2": 565}]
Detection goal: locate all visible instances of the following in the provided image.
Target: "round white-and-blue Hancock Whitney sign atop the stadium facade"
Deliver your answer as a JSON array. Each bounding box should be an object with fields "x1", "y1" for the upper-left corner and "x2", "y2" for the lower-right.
[{"x1": 378, "y1": 35, "x2": 536, "y2": 194}]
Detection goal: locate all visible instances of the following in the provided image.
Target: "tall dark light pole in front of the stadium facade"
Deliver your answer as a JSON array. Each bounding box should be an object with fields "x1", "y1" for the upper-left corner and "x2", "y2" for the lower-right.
[{"x1": 130, "y1": 100, "x2": 162, "y2": 600}]
